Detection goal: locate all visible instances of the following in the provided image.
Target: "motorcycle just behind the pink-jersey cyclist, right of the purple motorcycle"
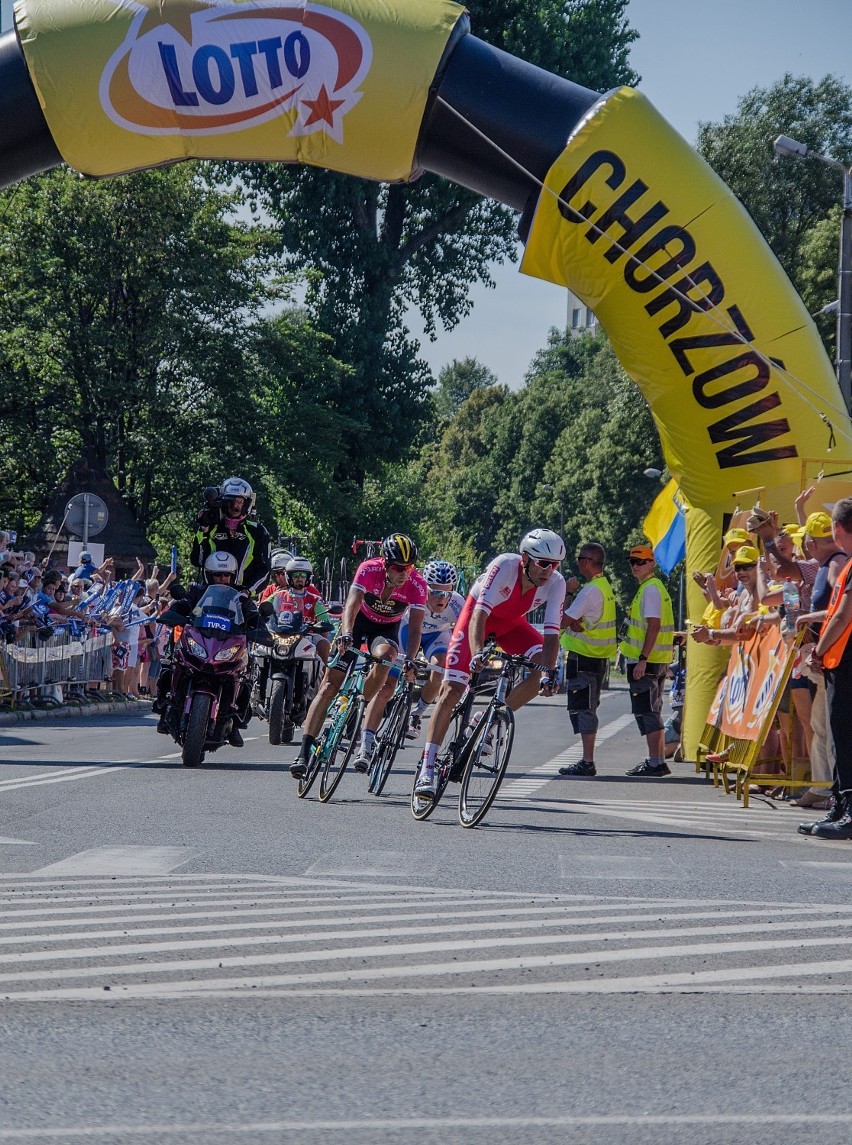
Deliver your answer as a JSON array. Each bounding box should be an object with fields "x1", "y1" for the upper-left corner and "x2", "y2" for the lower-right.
[{"x1": 252, "y1": 594, "x2": 333, "y2": 747}]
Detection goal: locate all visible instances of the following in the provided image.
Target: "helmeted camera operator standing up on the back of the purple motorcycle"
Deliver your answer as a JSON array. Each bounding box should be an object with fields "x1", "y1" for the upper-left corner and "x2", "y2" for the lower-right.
[{"x1": 189, "y1": 477, "x2": 269, "y2": 592}]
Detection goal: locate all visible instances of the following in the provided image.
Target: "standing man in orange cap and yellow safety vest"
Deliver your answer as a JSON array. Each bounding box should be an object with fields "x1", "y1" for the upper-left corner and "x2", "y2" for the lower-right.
[{"x1": 618, "y1": 545, "x2": 675, "y2": 779}]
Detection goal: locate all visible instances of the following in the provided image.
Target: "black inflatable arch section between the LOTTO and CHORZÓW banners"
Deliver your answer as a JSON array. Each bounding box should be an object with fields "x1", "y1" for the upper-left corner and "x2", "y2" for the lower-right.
[{"x1": 416, "y1": 34, "x2": 600, "y2": 222}]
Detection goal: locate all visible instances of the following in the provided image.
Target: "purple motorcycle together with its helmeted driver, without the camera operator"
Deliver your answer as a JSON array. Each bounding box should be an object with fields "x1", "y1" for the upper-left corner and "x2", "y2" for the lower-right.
[{"x1": 158, "y1": 553, "x2": 269, "y2": 767}]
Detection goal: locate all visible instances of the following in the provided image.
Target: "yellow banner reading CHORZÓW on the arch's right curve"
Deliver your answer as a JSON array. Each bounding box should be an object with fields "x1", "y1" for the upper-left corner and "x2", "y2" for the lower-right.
[{"x1": 522, "y1": 88, "x2": 852, "y2": 513}]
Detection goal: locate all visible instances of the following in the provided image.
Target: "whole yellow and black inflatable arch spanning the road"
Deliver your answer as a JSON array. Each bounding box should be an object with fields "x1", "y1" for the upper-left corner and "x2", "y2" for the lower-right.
[{"x1": 0, "y1": 0, "x2": 852, "y2": 755}]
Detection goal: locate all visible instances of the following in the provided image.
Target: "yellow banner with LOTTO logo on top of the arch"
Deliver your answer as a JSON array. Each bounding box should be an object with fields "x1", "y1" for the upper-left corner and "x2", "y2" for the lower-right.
[{"x1": 15, "y1": 0, "x2": 464, "y2": 180}]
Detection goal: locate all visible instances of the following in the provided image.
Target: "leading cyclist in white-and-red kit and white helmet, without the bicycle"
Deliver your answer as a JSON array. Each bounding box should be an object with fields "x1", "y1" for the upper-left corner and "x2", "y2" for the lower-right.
[{"x1": 415, "y1": 529, "x2": 565, "y2": 796}]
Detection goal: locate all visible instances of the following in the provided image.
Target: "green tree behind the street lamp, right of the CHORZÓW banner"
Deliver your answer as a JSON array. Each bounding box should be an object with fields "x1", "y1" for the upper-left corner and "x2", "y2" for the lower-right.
[{"x1": 697, "y1": 73, "x2": 852, "y2": 353}]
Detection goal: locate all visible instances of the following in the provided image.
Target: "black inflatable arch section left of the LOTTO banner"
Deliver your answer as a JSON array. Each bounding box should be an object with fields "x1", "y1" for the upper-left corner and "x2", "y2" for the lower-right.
[{"x1": 0, "y1": 32, "x2": 62, "y2": 187}]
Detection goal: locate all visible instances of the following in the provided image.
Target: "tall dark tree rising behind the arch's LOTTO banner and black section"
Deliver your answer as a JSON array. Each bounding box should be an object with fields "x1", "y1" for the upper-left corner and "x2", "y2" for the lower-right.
[{"x1": 232, "y1": 0, "x2": 636, "y2": 483}]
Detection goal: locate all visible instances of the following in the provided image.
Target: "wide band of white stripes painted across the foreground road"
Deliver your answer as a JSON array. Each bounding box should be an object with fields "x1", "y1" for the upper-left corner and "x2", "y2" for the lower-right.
[{"x1": 0, "y1": 875, "x2": 852, "y2": 1002}]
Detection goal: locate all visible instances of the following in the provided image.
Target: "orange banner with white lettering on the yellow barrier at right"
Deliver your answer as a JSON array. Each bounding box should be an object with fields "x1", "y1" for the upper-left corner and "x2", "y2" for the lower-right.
[{"x1": 707, "y1": 624, "x2": 795, "y2": 741}]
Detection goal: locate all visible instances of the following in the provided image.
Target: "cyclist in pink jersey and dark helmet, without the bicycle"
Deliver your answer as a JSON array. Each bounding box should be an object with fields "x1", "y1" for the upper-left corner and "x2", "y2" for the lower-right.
[{"x1": 290, "y1": 532, "x2": 428, "y2": 779}]
